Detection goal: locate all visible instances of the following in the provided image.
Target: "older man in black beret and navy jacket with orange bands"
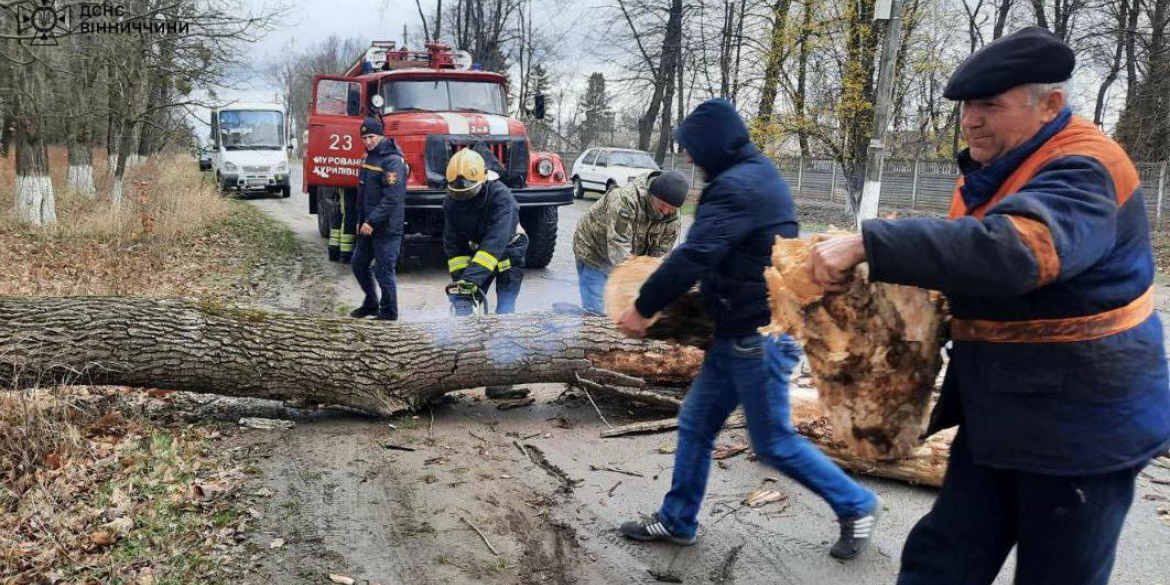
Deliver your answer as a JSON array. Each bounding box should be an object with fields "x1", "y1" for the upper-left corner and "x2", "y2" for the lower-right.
[{"x1": 811, "y1": 27, "x2": 1170, "y2": 585}]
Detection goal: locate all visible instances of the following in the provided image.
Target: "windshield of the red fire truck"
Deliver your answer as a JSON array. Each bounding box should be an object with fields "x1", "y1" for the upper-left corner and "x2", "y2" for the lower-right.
[{"x1": 379, "y1": 80, "x2": 508, "y2": 115}]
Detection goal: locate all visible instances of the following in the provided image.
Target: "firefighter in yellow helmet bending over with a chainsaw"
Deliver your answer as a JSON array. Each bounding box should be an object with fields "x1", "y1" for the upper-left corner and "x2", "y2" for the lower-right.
[{"x1": 442, "y1": 149, "x2": 528, "y2": 398}]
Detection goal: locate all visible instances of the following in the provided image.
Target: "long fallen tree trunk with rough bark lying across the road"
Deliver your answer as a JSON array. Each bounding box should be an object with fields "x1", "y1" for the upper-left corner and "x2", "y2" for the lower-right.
[{"x1": 0, "y1": 297, "x2": 703, "y2": 414}]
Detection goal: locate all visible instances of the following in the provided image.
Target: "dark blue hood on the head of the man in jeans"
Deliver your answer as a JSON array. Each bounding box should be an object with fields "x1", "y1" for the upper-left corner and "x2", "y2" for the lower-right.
[{"x1": 674, "y1": 98, "x2": 759, "y2": 180}]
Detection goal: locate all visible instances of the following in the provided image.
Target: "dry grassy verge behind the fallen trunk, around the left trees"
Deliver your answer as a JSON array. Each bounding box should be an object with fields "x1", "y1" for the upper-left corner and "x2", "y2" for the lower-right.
[{"x1": 0, "y1": 150, "x2": 296, "y2": 297}]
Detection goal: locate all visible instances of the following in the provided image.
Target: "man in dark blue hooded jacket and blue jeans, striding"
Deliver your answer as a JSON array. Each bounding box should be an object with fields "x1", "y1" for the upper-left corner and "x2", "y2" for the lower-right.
[{"x1": 618, "y1": 99, "x2": 881, "y2": 558}]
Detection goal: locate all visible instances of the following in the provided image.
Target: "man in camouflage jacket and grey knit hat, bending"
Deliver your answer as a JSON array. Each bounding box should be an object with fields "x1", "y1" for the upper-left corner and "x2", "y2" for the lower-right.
[{"x1": 573, "y1": 171, "x2": 690, "y2": 314}]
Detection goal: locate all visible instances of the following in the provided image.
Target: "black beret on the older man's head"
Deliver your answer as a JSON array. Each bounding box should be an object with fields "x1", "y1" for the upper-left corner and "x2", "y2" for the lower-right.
[{"x1": 943, "y1": 27, "x2": 1076, "y2": 101}]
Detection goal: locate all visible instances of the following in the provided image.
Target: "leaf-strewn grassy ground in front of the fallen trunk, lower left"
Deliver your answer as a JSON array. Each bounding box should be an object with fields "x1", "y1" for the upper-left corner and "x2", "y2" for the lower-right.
[{"x1": 0, "y1": 387, "x2": 247, "y2": 585}]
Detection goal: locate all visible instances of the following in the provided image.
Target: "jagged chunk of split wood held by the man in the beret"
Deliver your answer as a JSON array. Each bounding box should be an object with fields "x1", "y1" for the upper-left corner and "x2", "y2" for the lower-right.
[{"x1": 764, "y1": 234, "x2": 945, "y2": 461}]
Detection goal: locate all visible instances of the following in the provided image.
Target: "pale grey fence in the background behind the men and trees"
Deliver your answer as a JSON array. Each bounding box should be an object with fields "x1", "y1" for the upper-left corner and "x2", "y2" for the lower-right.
[{"x1": 562, "y1": 152, "x2": 1170, "y2": 230}]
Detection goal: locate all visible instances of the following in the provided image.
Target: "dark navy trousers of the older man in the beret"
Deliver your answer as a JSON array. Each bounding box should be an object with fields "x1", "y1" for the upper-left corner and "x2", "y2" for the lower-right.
[{"x1": 897, "y1": 431, "x2": 1142, "y2": 585}]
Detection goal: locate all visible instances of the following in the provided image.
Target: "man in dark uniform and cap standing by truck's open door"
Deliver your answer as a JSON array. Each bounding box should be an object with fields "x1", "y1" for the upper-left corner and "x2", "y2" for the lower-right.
[{"x1": 346, "y1": 118, "x2": 407, "y2": 321}]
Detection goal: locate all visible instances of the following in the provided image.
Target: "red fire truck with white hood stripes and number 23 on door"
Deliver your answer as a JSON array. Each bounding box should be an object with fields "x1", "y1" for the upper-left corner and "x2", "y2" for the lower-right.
[{"x1": 302, "y1": 41, "x2": 573, "y2": 268}]
